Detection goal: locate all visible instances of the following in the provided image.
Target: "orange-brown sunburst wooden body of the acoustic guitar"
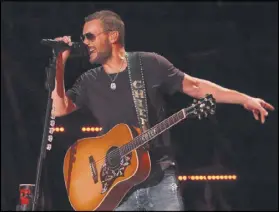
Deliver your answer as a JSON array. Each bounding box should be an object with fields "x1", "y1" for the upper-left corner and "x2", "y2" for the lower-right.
[{"x1": 63, "y1": 124, "x2": 151, "y2": 211}]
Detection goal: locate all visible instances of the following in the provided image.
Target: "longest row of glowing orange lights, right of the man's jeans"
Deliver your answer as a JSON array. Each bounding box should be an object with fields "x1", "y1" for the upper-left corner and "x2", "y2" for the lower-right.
[{"x1": 178, "y1": 175, "x2": 237, "y2": 181}]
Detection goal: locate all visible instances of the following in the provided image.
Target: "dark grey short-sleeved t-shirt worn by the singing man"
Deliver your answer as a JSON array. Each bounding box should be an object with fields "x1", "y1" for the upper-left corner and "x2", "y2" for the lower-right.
[{"x1": 67, "y1": 52, "x2": 184, "y2": 186}]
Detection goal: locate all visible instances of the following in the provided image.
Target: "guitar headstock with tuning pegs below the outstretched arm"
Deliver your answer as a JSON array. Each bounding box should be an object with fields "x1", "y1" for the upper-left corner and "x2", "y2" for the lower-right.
[{"x1": 186, "y1": 94, "x2": 216, "y2": 119}]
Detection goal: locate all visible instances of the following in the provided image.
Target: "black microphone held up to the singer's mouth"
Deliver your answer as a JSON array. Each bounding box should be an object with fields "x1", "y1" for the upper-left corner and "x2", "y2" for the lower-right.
[{"x1": 41, "y1": 39, "x2": 88, "y2": 56}]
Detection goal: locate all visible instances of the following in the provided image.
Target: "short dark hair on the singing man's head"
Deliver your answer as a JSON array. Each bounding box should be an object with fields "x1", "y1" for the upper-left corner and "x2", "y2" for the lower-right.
[{"x1": 84, "y1": 10, "x2": 125, "y2": 46}]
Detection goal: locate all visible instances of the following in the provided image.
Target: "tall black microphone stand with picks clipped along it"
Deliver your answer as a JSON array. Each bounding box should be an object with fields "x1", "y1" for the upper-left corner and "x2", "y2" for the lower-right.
[{"x1": 32, "y1": 48, "x2": 59, "y2": 211}]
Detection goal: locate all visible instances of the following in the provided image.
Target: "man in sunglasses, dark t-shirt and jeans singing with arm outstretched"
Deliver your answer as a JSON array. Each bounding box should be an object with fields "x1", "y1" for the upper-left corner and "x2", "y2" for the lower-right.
[{"x1": 52, "y1": 10, "x2": 274, "y2": 211}]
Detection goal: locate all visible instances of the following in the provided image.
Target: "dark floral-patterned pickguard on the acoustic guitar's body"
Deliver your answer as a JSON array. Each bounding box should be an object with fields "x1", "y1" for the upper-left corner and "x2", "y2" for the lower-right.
[{"x1": 100, "y1": 153, "x2": 132, "y2": 194}]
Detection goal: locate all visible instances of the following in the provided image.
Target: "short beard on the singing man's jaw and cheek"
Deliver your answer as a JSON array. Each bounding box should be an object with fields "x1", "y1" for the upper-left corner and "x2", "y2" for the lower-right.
[{"x1": 89, "y1": 40, "x2": 112, "y2": 65}]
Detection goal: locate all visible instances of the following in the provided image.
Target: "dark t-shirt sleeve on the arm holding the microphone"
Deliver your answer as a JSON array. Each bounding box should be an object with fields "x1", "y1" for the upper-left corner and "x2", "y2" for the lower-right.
[{"x1": 66, "y1": 74, "x2": 86, "y2": 108}]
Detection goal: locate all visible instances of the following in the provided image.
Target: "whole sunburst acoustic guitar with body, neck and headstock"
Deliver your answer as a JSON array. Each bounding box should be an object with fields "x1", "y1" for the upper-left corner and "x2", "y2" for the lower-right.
[{"x1": 63, "y1": 95, "x2": 216, "y2": 211}]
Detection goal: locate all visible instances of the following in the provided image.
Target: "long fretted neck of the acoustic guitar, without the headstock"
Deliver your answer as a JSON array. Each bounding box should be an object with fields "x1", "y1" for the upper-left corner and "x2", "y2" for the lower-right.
[{"x1": 120, "y1": 108, "x2": 190, "y2": 156}]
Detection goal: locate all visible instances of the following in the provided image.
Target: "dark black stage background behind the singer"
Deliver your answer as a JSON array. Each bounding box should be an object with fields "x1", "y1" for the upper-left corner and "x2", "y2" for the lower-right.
[{"x1": 1, "y1": 2, "x2": 278, "y2": 210}]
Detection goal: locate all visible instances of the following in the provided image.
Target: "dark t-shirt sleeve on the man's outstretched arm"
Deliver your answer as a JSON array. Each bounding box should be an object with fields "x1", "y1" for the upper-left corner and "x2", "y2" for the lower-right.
[{"x1": 154, "y1": 53, "x2": 185, "y2": 95}]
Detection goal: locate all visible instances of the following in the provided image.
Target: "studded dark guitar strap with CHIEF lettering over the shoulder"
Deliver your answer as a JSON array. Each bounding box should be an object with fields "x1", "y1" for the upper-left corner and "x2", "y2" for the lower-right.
[{"x1": 126, "y1": 52, "x2": 150, "y2": 150}]
